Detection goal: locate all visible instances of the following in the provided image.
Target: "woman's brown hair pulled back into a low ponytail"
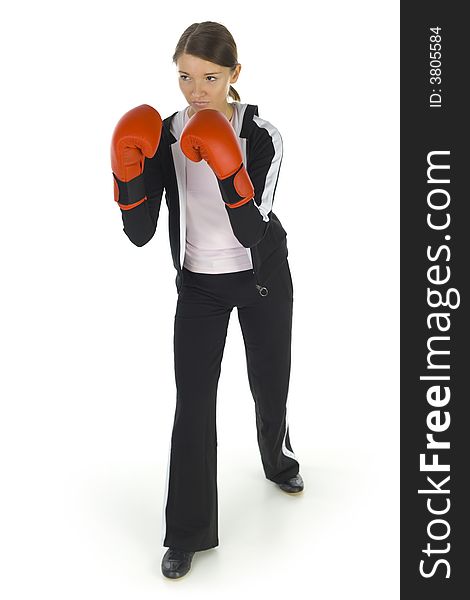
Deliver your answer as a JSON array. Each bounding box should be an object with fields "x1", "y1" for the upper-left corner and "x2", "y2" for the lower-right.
[{"x1": 173, "y1": 21, "x2": 240, "y2": 102}]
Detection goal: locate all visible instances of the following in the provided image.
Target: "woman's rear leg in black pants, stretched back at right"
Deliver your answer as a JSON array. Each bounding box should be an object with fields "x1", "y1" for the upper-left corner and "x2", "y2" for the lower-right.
[{"x1": 238, "y1": 259, "x2": 299, "y2": 483}]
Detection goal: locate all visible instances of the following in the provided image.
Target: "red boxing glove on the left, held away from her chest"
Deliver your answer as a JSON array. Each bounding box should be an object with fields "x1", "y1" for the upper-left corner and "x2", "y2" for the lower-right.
[{"x1": 111, "y1": 104, "x2": 162, "y2": 210}]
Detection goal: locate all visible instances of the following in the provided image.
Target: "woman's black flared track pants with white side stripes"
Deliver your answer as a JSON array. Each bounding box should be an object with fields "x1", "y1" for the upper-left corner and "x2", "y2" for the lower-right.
[{"x1": 162, "y1": 259, "x2": 299, "y2": 551}]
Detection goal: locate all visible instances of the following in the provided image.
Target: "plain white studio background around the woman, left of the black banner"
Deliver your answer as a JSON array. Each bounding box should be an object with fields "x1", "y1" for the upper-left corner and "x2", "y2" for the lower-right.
[{"x1": 0, "y1": 0, "x2": 399, "y2": 600}]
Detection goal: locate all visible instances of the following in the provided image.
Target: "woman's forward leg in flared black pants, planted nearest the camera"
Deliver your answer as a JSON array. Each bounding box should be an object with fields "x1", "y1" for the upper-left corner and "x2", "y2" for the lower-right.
[{"x1": 163, "y1": 269, "x2": 232, "y2": 551}]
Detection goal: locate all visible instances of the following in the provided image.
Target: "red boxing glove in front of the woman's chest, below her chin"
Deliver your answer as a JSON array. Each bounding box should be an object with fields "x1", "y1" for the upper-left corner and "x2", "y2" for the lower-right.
[{"x1": 180, "y1": 108, "x2": 255, "y2": 208}]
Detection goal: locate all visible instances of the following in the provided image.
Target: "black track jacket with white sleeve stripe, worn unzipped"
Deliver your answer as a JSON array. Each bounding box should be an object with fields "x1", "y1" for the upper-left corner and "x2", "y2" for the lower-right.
[{"x1": 121, "y1": 102, "x2": 288, "y2": 295}]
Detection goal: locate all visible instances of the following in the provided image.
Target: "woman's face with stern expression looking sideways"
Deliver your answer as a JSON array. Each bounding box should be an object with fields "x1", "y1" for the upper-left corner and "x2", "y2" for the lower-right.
[{"x1": 176, "y1": 54, "x2": 241, "y2": 114}]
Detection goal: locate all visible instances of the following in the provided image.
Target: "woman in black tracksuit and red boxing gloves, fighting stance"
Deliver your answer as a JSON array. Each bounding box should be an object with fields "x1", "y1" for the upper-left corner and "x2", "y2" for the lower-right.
[{"x1": 112, "y1": 21, "x2": 303, "y2": 578}]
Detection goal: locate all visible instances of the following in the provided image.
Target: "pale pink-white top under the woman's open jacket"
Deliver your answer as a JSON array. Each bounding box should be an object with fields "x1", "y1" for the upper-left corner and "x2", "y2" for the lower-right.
[{"x1": 183, "y1": 106, "x2": 253, "y2": 273}]
